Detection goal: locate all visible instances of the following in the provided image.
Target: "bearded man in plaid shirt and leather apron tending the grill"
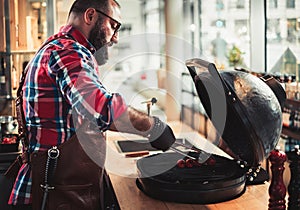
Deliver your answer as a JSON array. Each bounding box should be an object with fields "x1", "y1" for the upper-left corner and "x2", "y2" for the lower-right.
[{"x1": 9, "y1": 0, "x2": 175, "y2": 210}]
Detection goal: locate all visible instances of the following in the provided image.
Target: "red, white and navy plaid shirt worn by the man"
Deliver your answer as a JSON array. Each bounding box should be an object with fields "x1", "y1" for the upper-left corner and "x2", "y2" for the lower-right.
[{"x1": 9, "y1": 26, "x2": 127, "y2": 204}]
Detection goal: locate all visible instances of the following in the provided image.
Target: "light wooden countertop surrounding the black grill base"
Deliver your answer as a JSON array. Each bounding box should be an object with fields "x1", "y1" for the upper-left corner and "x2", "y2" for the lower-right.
[{"x1": 106, "y1": 122, "x2": 284, "y2": 210}]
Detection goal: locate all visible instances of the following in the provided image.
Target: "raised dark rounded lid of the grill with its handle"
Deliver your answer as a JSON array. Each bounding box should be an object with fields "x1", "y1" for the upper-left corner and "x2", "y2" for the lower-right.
[{"x1": 186, "y1": 58, "x2": 285, "y2": 166}]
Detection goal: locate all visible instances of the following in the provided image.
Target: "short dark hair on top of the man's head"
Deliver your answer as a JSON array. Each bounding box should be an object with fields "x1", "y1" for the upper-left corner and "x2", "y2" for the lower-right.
[{"x1": 69, "y1": 0, "x2": 120, "y2": 15}]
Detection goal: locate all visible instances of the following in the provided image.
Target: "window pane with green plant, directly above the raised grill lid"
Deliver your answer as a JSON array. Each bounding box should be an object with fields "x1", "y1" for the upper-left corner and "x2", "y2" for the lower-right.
[{"x1": 199, "y1": 0, "x2": 250, "y2": 69}]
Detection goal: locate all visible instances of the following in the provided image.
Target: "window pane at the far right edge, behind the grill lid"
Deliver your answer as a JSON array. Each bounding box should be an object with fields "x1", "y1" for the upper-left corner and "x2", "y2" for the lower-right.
[{"x1": 267, "y1": 0, "x2": 300, "y2": 80}]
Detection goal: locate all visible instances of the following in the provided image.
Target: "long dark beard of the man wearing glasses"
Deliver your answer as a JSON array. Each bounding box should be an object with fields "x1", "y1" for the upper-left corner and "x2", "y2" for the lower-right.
[{"x1": 88, "y1": 19, "x2": 108, "y2": 65}]
